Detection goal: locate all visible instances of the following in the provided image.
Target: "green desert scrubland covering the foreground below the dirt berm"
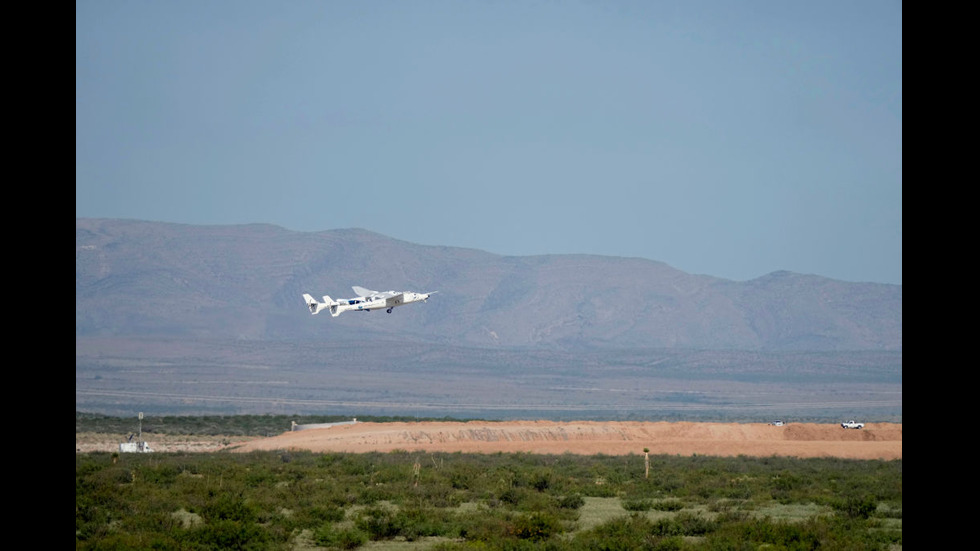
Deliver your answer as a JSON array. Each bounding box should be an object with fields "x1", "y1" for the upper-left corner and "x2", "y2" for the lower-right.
[{"x1": 75, "y1": 446, "x2": 902, "y2": 551}]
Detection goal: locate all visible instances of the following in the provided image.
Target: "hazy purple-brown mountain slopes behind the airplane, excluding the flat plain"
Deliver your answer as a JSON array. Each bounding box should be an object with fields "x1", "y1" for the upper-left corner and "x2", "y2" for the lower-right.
[{"x1": 75, "y1": 218, "x2": 902, "y2": 351}]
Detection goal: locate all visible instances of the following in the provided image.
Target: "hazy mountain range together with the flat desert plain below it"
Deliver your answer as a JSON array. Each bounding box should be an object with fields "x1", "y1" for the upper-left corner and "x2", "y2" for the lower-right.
[{"x1": 75, "y1": 218, "x2": 902, "y2": 421}]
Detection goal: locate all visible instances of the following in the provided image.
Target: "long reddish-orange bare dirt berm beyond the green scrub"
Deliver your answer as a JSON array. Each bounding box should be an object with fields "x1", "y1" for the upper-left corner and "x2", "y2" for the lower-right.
[{"x1": 234, "y1": 421, "x2": 902, "y2": 460}]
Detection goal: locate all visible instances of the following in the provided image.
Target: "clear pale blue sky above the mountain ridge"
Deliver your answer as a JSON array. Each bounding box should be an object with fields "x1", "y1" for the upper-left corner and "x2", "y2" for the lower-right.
[{"x1": 75, "y1": 0, "x2": 902, "y2": 284}]
